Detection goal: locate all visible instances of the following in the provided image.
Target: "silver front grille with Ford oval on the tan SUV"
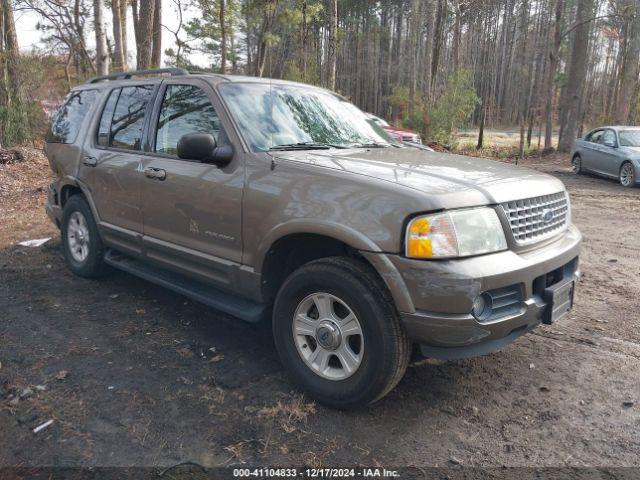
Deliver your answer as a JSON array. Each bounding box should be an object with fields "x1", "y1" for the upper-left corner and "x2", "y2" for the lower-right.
[{"x1": 502, "y1": 192, "x2": 569, "y2": 245}]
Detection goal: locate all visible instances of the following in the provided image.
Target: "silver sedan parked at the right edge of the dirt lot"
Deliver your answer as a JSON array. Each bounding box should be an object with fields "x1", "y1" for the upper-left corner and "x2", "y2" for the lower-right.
[{"x1": 571, "y1": 126, "x2": 640, "y2": 187}]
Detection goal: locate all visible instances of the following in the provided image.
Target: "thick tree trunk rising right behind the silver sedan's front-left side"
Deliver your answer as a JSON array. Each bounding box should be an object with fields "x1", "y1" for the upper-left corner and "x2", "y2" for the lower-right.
[{"x1": 558, "y1": 0, "x2": 594, "y2": 152}]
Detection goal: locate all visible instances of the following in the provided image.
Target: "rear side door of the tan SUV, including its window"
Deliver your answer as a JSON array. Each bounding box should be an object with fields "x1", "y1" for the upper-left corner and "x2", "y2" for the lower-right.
[{"x1": 78, "y1": 83, "x2": 158, "y2": 255}]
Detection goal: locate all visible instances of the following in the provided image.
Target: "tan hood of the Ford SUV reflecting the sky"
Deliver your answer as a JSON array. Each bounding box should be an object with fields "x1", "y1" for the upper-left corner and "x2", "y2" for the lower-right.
[{"x1": 272, "y1": 148, "x2": 565, "y2": 208}]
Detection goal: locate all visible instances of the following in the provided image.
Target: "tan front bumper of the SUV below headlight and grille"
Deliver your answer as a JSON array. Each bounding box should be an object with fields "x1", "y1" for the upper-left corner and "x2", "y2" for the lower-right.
[{"x1": 368, "y1": 226, "x2": 581, "y2": 359}]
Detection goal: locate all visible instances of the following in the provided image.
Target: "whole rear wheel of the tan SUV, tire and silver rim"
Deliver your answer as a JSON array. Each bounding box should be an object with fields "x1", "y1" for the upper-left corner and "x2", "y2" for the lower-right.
[{"x1": 60, "y1": 195, "x2": 108, "y2": 278}]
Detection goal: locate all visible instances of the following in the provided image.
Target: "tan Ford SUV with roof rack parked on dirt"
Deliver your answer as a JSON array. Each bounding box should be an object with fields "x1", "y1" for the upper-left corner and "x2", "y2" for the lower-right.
[{"x1": 46, "y1": 69, "x2": 581, "y2": 408}]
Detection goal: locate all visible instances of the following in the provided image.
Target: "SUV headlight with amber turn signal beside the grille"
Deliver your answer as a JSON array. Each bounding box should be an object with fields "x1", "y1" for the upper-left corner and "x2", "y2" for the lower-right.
[{"x1": 405, "y1": 207, "x2": 507, "y2": 258}]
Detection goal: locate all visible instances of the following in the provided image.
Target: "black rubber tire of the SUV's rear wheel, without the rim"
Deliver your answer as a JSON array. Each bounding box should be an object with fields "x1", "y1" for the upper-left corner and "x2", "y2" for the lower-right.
[{"x1": 60, "y1": 195, "x2": 104, "y2": 277}]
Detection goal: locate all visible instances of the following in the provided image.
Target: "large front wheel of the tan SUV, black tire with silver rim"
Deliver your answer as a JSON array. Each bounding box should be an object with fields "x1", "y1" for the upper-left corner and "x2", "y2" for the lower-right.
[{"x1": 273, "y1": 257, "x2": 411, "y2": 409}]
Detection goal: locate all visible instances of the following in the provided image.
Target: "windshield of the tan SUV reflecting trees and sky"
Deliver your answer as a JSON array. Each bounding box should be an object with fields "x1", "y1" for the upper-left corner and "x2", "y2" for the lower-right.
[{"x1": 219, "y1": 83, "x2": 399, "y2": 152}]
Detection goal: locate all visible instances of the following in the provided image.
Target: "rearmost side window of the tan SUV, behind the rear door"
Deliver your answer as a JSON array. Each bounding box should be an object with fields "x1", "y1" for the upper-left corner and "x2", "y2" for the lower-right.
[{"x1": 46, "y1": 90, "x2": 98, "y2": 143}]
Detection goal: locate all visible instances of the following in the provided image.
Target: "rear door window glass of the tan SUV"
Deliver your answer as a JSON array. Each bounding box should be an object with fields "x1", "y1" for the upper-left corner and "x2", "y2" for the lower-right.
[{"x1": 98, "y1": 85, "x2": 153, "y2": 150}]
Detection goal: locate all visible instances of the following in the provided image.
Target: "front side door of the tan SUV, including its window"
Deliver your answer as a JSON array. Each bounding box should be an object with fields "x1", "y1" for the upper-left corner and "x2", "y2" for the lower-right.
[{"x1": 141, "y1": 79, "x2": 244, "y2": 286}]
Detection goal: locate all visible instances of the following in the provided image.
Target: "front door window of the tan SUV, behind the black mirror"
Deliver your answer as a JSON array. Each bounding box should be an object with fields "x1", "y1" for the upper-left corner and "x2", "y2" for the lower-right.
[{"x1": 155, "y1": 85, "x2": 220, "y2": 155}]
